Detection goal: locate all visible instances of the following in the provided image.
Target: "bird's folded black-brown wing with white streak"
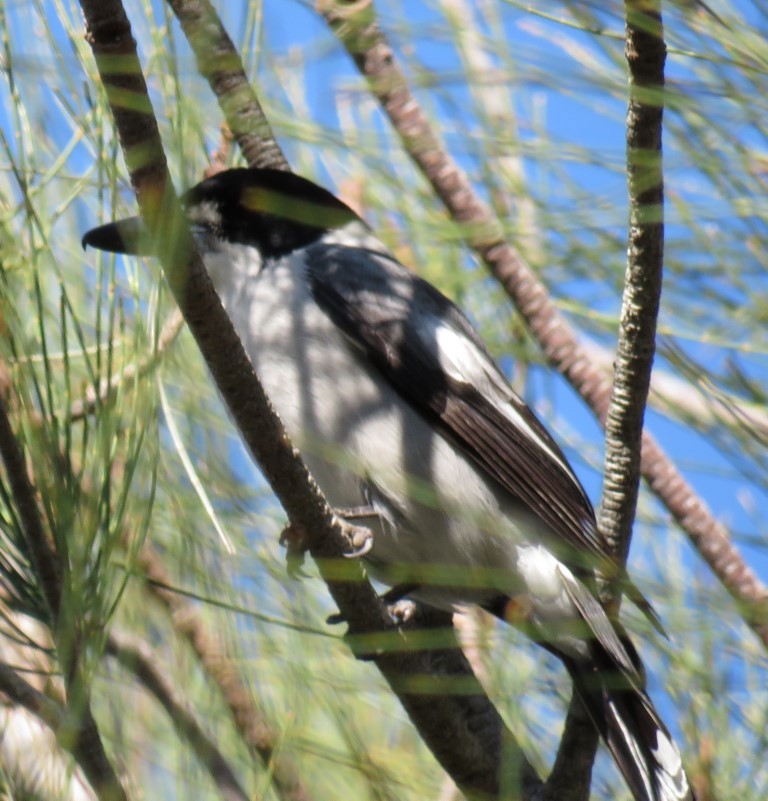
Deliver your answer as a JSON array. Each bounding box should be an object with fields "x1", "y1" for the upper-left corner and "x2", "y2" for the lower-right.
[{"x1": 306, "y1": 244, "x2": 610, "y2": 572}]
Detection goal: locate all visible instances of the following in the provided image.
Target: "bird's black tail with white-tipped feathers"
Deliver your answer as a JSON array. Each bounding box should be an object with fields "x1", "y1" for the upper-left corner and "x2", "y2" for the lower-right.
[{"x1": 564, "y1": 646, "x2": 694, "y2": 801}]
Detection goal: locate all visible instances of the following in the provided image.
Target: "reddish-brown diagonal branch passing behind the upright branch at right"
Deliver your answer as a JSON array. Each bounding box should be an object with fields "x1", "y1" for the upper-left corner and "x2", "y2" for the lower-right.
[{"x1": 320, "y1": 0, "x2": 768, "y2": 647}]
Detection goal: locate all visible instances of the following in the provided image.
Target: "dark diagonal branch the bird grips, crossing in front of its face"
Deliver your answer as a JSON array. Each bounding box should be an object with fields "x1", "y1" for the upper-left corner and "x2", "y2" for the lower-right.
[{"x1": 81, "y1": 0, "x2": 538, "y2": 796}]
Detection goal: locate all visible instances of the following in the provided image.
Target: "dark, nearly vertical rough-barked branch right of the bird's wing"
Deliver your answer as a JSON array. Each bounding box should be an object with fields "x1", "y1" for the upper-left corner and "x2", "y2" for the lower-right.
[{"x1": 598, "y1": 0, "x2": 666, "y2": 563}]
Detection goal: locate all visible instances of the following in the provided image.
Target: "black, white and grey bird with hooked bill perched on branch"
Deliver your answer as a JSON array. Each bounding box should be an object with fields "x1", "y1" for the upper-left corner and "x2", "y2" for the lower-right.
[{"x1": 82, "y1": 168, "x2": 694, "y2": 801}]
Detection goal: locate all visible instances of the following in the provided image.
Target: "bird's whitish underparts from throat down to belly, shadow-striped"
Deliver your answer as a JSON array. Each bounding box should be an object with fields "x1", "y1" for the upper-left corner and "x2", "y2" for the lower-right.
[{"x1": 206, "y1": 244, "x2": 560, "y2": 605}]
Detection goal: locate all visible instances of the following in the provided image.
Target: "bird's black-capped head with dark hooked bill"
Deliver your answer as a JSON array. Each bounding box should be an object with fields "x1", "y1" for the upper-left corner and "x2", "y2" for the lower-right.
[{"x1": 83, "y1": 168, "x2": 358, "y2": 257}]
